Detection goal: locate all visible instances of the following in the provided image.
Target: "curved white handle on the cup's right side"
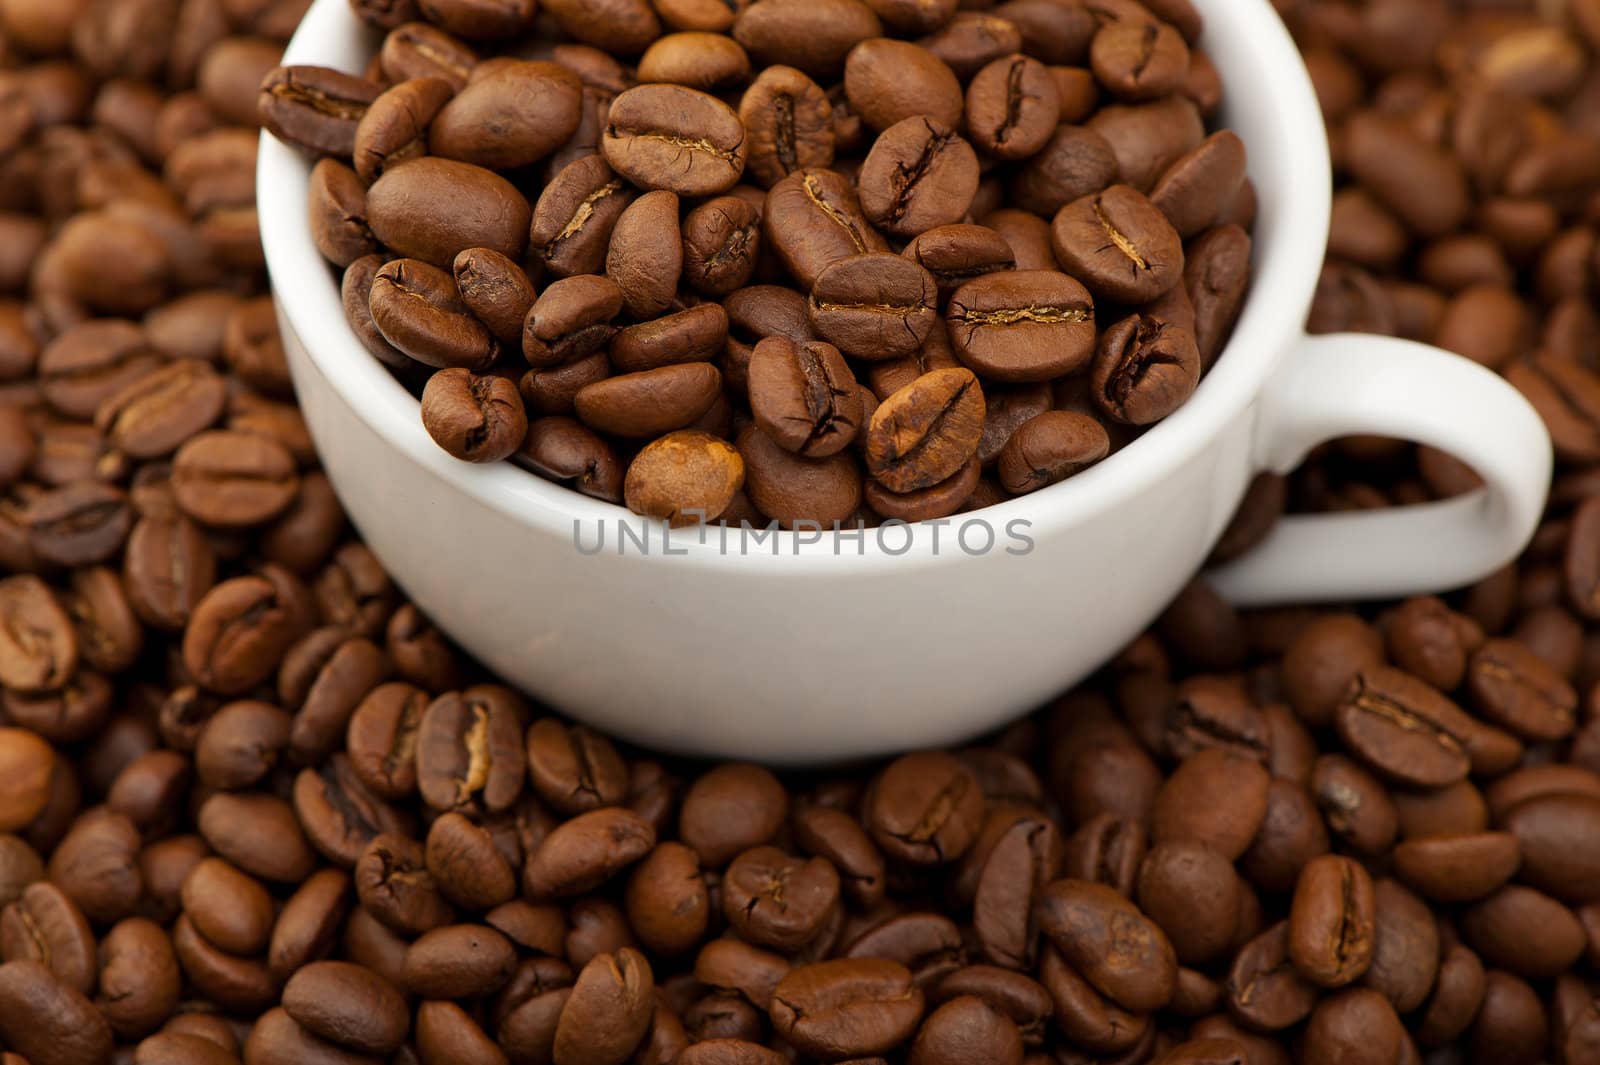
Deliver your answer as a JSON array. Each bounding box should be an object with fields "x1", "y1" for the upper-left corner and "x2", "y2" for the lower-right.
[{"x1": 1208, "y1": 333, "x2": 1552, "y2": 606}]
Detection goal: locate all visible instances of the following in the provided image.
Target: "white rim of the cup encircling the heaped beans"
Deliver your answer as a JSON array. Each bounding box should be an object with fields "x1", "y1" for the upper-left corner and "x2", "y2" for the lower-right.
[{"x1": 256, "y1": 0, "x2": 1331, "y2": 576}]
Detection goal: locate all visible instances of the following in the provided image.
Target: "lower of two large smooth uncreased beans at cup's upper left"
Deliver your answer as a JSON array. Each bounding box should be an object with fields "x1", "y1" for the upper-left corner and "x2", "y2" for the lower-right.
[{"x1": 366, "y1": 157, "x2": 533, "y2": 270}]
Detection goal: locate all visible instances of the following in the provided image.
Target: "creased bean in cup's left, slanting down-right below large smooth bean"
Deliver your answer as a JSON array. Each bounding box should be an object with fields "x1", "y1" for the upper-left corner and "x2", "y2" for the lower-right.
[{"x1": 368, "y1": 253, "x2": 496, "y2": 369}]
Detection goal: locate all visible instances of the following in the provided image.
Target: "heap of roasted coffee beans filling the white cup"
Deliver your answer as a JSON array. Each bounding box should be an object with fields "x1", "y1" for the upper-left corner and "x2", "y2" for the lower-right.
[{"x1": 261, "y1": 0, "x2": 1254, "y2": 528}]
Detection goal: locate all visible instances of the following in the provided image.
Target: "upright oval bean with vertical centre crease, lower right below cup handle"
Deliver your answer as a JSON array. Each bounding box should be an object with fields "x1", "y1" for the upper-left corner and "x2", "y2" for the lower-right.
[{"x1": 1288, "y1": 854, "x2": 1376, "y2": 988}]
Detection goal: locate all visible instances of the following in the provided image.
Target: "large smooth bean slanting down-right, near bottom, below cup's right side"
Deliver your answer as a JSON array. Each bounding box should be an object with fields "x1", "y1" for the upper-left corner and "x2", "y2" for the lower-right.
[{"x1": 1035, "y1": 880, "x2": 1178, "y2": 1012}]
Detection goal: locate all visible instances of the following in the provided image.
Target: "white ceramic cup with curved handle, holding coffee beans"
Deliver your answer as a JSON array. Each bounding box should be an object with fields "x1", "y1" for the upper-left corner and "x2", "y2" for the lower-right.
[{"x1": 259, "y1": 0, "x2": 1550, "y2": 764}]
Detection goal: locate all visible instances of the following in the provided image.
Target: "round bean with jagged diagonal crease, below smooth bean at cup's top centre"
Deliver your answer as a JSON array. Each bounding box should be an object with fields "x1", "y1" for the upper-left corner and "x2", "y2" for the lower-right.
[{"x1": 858, "y1": 117, "x2": 978, "y2": 237}]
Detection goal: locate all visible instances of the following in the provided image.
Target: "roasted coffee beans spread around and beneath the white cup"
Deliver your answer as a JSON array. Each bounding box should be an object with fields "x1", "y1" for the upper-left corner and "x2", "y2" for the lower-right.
[{"x1": 0, "y1": 0, "x2": 1600, "y2": 1065}]
